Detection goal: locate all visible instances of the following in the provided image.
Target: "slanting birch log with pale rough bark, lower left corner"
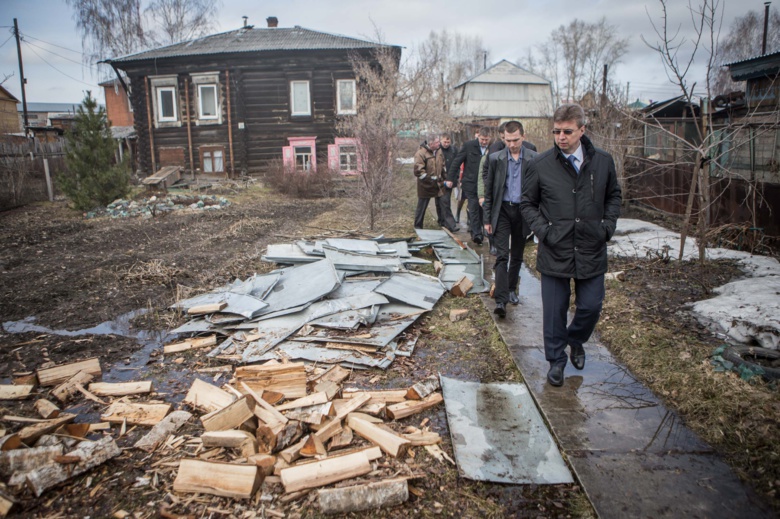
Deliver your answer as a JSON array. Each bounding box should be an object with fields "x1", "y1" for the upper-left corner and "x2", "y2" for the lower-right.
[{"x1": 27, "y1": 436, "x2": 122, "y2": 497}]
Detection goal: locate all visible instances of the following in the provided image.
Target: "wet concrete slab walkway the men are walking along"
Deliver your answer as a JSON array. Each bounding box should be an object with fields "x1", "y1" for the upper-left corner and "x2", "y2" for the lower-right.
[{"x1": 476, "y1": 258, "x2": 774, "y2": 519}]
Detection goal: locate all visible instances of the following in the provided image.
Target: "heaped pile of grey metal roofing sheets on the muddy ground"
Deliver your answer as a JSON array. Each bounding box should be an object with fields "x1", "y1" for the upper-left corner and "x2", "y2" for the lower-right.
[{"x1": 173, "y1": 233, "x2": 450, "y2": 369}]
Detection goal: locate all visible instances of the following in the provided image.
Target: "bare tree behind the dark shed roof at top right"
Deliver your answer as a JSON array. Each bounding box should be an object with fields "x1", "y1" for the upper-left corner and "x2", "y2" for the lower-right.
[{"x1": 711, "y1": 9, "x2": 780, "y2": 95}]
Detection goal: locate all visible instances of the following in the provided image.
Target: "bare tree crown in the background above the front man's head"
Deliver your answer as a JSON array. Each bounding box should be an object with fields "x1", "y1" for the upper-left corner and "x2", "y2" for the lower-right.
[{"x1": 518, "y1": 18, "x2": 628, "y2": 103}]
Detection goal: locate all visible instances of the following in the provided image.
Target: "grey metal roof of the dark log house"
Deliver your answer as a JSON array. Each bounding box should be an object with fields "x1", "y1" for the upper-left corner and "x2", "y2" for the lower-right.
[{"x1": 106, "y1": 26, "x2": 400, "y2": 63}]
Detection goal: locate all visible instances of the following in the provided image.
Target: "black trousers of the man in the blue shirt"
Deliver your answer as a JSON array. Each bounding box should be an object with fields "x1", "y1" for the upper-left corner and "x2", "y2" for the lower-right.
[{"x1": 493, "y1": 202, "x2": 527, "y2": 304}]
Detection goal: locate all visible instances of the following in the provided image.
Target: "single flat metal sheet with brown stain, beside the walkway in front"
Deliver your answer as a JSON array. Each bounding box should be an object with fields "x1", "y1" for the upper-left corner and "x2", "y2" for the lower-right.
[{"x1": 440, "y1": 377, "x2": 574, "y2": 485}]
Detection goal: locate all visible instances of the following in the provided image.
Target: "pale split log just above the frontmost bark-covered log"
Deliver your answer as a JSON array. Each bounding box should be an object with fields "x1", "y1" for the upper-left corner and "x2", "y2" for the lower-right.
[{"x1": 281, "y1": 452, "x2": 371, "y2": 493}]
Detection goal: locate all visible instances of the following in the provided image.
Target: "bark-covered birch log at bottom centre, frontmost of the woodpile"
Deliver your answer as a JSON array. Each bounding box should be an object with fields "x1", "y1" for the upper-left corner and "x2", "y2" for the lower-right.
[{"x1": 317, "y1": 478, "x2": 409, "y2": 514}]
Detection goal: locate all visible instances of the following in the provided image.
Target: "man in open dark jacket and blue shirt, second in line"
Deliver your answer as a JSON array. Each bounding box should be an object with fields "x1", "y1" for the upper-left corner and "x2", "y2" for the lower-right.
[{"x1": 482, "y1": 121, "x2": 536, "y2": 317}]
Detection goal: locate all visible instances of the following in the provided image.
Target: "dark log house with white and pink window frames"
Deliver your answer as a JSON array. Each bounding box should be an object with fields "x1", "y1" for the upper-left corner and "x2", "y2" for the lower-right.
[{"x1": 107, "y1": 18, "x2": 401, "y2": 176}]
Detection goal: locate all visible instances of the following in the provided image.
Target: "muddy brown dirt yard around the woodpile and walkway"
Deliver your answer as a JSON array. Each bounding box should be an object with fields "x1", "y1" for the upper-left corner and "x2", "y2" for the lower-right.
[{"x1": 0, "y1": 179, "x2": 780, "y2": 518}]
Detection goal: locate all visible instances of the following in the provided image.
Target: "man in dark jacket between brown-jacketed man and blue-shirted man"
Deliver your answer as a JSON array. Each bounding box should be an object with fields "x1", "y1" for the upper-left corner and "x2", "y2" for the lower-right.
[{"x1": 445, "y1": 126, "x2": 490, "y2": 245}]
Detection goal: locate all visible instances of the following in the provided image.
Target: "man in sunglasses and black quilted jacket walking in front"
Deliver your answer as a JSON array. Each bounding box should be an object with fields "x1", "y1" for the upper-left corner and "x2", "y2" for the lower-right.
[{"x1": 520, "y1": 104, "x2": 621, "y2": 386}]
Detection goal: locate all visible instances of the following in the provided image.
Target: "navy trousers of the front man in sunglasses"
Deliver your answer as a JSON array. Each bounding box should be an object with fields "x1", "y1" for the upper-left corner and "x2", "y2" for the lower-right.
[{"x1": 542, "y1": 274, "x2": 604, "y2": 366}]
